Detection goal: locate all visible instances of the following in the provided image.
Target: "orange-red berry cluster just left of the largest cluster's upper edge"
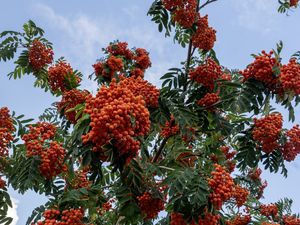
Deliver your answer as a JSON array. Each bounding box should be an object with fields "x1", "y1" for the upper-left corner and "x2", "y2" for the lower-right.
[{"x1": 57, "y1": 88, "x2": 89, "y2": 124}]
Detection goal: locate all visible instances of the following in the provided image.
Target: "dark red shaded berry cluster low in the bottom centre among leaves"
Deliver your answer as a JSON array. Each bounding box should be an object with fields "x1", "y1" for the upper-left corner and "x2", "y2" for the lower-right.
[{"x1": 137, "y1": 192, "x2": 165, "y2": 219}]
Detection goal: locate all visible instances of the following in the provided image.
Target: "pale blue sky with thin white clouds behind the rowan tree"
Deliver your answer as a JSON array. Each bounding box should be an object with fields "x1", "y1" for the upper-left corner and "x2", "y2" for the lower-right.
[{"x1": 0, "y1": 0, "x2": 300, "y2": 225}]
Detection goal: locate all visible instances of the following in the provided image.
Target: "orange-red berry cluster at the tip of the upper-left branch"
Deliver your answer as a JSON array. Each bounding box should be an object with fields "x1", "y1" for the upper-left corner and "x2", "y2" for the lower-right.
[{"x1": 28, "y1": 39, "x2": 53, "y2": 70}]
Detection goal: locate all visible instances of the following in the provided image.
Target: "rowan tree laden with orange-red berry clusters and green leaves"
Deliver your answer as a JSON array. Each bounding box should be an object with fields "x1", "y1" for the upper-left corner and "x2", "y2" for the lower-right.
[{"x1": 0, "y1": 0, "x2": 300, "y2": 225}]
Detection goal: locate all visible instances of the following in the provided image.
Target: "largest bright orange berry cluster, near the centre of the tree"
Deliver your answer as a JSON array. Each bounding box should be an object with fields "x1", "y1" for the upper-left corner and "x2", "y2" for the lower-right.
[{"x1": 82, "y1": 79, "x2": 150, "y2": 160}]
